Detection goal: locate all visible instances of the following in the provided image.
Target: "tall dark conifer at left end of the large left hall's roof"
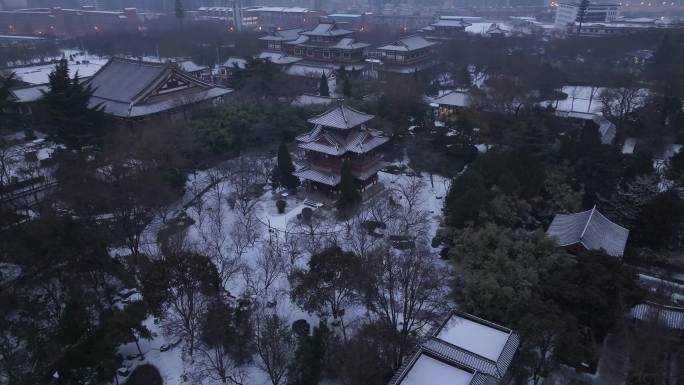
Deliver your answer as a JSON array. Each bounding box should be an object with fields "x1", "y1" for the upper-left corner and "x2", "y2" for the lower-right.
[{"x1": 43, "y1": 59, "x2": 104, "y2": 150}]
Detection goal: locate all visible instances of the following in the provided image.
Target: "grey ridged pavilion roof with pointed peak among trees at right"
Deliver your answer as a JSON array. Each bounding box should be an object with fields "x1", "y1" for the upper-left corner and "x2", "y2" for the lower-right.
[{"x1": 546, "y1": 206, "x2": 629, "y2": 257}]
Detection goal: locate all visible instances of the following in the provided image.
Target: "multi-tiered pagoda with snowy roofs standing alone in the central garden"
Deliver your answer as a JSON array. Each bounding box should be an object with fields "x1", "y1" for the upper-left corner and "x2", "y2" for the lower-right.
[{"x1": 296, "y1": 104, "x2": 389, "y2": 203}]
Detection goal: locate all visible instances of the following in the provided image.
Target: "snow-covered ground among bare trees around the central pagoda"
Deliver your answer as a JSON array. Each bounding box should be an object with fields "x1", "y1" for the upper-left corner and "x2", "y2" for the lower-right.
[{"x1": 112, "y1": 162, "x2": 449, "y2": 385}]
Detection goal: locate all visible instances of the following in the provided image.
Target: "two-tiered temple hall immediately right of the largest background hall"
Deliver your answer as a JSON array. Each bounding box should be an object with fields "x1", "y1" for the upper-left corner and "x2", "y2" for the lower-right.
[{"x1": 378, "y1": 36, "x2": 436, "y2": 77}]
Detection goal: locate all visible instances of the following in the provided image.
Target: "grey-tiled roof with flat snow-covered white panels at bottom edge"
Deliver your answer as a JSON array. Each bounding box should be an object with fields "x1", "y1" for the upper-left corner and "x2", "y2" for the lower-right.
[{"x1": 390, "y1": 311, "x2": 520, "y2": 385}]
